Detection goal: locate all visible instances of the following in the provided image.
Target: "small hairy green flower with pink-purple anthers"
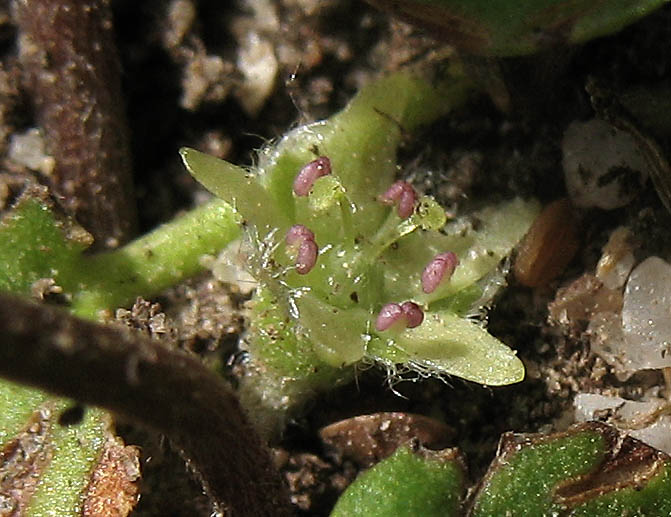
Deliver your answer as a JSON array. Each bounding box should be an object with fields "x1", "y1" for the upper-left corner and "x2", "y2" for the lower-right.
[{"x1": 181, "y1": 67, "x2": 537, "y2": 420}]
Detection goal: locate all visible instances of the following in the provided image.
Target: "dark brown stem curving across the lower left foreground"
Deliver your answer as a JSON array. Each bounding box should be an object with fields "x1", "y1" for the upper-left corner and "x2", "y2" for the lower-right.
[{"x1": 0, "y1": 295, "x2": 292, "y2": 516}]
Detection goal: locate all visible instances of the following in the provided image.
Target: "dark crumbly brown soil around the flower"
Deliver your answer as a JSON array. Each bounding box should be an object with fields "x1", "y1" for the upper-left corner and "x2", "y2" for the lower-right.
[{"x1": 0, "y1": 0, "x2": 671, "y2": 516}]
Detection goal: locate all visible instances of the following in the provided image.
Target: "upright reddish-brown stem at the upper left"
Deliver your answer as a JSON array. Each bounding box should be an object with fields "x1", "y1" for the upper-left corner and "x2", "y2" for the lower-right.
[{"x1": 14, "y1": 0, "x2": 136, "y2": 249}]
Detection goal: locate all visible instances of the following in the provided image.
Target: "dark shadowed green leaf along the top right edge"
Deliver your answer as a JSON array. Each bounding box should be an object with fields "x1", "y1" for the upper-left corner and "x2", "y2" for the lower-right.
[{"x1": 368, "y1": 0, "x2": 667, "y2": 56}]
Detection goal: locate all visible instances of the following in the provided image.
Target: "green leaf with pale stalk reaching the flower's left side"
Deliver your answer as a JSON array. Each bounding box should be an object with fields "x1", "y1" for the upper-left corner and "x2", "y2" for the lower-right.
[{"x1": 0, "y1": 190, "x2": 240, "y2": 319}]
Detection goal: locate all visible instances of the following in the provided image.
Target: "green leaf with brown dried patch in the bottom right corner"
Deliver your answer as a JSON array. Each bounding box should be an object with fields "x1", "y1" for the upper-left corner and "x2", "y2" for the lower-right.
[{"x1": 470, "y1": 422, "x2": 671, "y2": 517}]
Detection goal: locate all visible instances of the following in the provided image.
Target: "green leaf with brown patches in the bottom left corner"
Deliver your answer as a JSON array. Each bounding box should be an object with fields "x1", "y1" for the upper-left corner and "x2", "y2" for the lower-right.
[{"x1": 0, "y1": 380, "x2": 137, "y2": 517}]
